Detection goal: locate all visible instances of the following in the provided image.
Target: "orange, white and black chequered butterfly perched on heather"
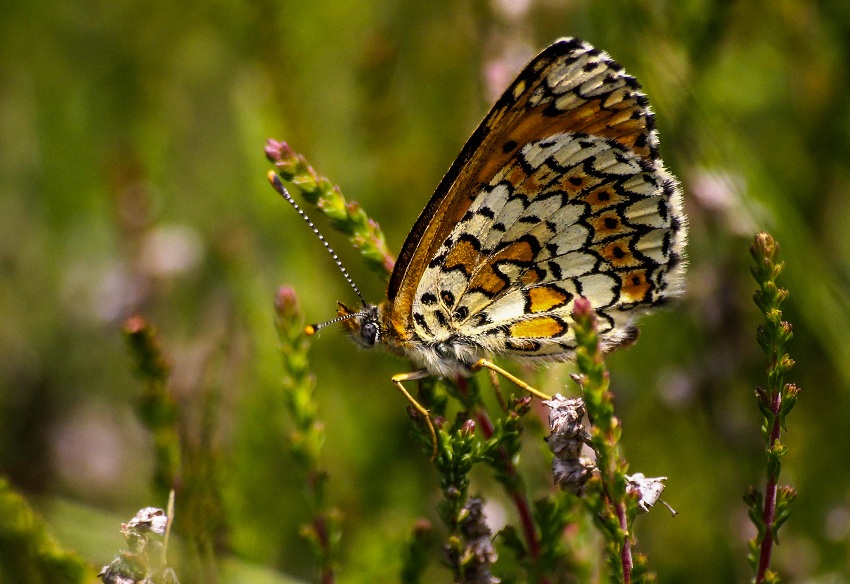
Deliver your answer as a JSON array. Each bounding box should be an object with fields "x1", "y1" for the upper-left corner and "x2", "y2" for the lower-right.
[{"x1": 270, "y1": 38, "x2": 687, "y2": 452}]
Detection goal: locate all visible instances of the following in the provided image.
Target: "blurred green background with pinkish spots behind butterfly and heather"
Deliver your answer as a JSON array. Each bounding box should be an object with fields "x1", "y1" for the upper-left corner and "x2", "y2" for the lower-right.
[{"x1": 0, "y1": 0, "x2": 850, "y2": 583}]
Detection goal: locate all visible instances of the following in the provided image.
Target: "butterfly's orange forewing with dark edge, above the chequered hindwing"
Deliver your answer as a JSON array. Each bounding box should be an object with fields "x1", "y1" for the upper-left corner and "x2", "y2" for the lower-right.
[{"x1": 387, "y1": 38, "x2": 657, "y2": 338}]
